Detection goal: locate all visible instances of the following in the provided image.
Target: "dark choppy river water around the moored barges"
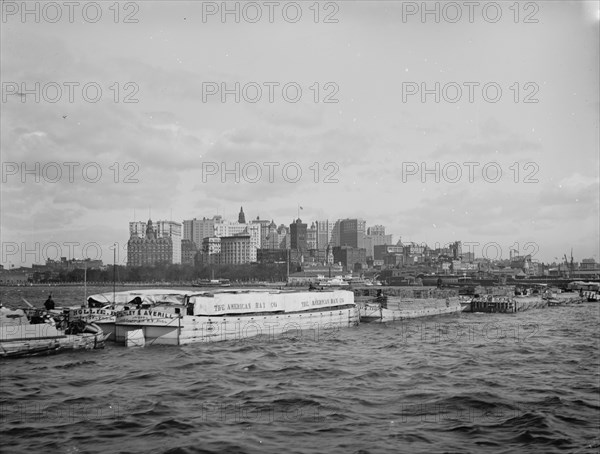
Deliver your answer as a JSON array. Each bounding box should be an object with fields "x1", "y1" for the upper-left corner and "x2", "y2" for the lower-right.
[{"x1": 0, "y1": 287, "x2": 600, "y2": 453}]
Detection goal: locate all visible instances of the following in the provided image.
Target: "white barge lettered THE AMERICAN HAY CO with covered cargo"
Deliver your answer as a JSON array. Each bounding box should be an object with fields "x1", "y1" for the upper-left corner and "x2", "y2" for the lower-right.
[{"x1": 115, "y1": 289, "x2": 359, "y2": 346}]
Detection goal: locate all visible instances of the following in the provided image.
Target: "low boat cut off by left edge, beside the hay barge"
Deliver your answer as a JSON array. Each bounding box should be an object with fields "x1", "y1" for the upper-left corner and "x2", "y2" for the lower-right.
[{"x1": 0, "y1": 307, "x2": 108, "y2": 358}]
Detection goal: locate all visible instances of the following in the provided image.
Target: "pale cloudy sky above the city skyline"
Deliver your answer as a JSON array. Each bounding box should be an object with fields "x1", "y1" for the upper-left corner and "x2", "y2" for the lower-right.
[{"x1": 0, "y1": 1, "x2": 600, "y2": 268}]
